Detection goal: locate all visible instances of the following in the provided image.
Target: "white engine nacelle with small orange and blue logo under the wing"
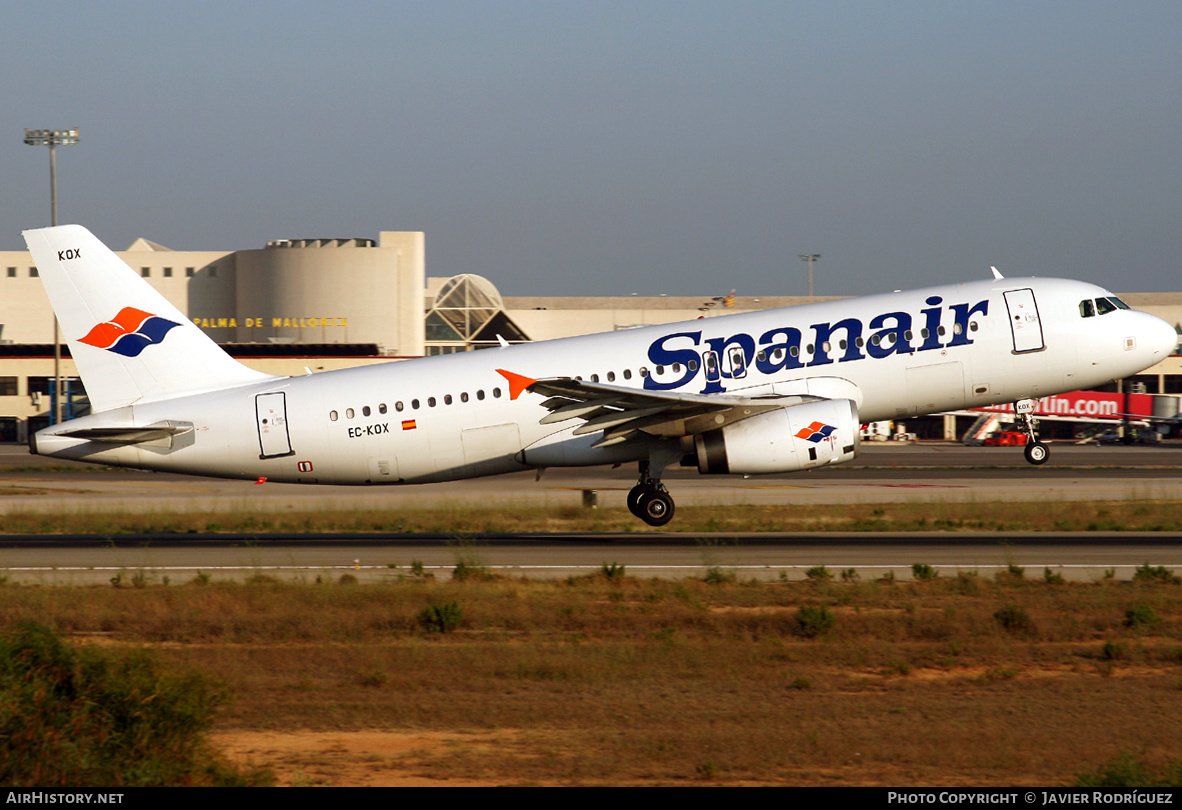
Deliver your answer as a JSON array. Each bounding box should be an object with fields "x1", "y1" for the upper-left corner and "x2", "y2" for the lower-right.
[{"x1": 694, "y1": 400, "x2": 860, "y2": 475}]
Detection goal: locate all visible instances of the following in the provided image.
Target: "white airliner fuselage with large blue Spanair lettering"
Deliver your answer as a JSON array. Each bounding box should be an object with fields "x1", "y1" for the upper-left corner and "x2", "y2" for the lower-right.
[{"x1": 33, "y1": 279, "x2": 1176, "y2": 484}]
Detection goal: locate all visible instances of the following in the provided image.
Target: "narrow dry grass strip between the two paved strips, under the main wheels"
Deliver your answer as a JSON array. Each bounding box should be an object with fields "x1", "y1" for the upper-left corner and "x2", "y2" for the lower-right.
[{"x1": 5, "y1": 500, "x2": 1182, "y2": 534}]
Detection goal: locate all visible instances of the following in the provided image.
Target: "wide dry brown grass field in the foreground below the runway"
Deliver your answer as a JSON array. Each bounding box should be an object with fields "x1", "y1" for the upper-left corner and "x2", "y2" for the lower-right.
[{"x1": 0, "y1": 574, "x2": 1182, "y2": 786}]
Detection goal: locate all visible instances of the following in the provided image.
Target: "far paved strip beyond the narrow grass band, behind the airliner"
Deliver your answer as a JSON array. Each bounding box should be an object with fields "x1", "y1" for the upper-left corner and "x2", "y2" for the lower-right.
[{"x1": 0, "y1": 435, "x2": 1182, "y2": 514}]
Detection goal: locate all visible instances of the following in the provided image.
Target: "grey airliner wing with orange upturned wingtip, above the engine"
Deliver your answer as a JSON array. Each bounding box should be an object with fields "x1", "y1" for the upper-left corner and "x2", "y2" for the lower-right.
[{"x1": 498, "y1": 369, "x2": 823, "y2": 447}]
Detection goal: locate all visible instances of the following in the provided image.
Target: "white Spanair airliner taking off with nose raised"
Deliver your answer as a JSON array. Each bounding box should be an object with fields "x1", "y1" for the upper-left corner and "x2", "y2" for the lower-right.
[{"x1": 25, "y1": 225, "x2": 1177, "y2": 526}]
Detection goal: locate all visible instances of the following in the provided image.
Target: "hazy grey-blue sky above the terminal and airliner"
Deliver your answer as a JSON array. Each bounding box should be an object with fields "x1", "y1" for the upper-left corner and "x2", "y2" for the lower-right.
[{"x1": 0, "y1": 0, "x2": 1182, "y2": 296}]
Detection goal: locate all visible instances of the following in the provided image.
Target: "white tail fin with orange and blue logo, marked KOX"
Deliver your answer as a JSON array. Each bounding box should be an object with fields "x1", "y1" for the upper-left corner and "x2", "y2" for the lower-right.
[{"x1": 24, "y1": 225, "x2": 274, "y2": 412}]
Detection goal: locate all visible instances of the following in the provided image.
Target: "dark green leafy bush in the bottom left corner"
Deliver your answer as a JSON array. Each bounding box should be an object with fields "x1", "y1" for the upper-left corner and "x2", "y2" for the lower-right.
[{"x1": 0, "y1": 622, "x2": 269, "y2": 788}]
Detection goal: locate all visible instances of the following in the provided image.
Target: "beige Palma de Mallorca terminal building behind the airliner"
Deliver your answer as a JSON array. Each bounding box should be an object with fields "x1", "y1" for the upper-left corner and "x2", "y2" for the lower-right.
[{"x1": 0, "y1": 231, "x2": 1182, "y2": 441}]
